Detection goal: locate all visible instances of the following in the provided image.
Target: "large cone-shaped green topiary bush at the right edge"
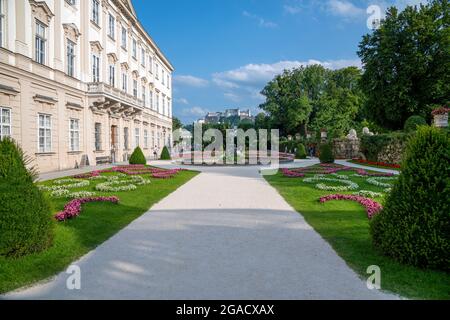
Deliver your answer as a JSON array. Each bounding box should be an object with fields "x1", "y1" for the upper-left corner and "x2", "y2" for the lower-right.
[{"x1": 370, "y1": 126, "x2": 450, "y2": 271}]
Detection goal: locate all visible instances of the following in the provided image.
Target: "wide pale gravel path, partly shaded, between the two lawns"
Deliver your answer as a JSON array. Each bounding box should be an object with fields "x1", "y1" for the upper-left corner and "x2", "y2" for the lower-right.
[{"x1": 3, "y1": 161, "x2": 397, "y2": 299}]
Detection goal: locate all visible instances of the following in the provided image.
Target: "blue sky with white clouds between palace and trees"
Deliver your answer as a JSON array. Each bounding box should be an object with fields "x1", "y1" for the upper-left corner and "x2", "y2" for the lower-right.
[{"x1": 133, "y1": 0, "x2": 425, "y2": 123}]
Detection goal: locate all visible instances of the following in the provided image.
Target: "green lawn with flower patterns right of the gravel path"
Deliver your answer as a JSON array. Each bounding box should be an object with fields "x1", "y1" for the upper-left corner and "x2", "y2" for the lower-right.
[{"x1": 265, "y1": 165, "x2": 450, "y2": 299}]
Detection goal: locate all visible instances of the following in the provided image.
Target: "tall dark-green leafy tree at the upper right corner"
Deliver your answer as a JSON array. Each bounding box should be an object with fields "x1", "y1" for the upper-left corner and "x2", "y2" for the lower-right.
[{"x1": 358, "y1": 0, "x2": 450, "y2": 129}]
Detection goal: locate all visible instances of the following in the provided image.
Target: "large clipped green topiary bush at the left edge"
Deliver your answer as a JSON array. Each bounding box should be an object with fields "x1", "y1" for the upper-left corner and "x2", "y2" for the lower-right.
[{"x1": 0, "y1": 138, "x2": 54, "y2": 257}]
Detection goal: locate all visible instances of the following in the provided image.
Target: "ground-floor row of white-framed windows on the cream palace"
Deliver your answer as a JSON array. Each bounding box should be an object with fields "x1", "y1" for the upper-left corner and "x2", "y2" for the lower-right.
[{"x1": 0, "y1": 108, "x2": 170, "y2": 153}]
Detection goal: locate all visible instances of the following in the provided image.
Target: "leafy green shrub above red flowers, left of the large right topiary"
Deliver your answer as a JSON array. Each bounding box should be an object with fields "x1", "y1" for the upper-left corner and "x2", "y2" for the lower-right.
[{"x1": 361, "y1": 132, "x2": 409, "y2": 161}]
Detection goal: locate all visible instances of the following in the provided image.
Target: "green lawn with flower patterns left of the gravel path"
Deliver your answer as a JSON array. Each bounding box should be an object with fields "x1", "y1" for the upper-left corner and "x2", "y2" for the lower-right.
[{"x1": 0, "y1": 171, "x2": 198, "y2": 293}]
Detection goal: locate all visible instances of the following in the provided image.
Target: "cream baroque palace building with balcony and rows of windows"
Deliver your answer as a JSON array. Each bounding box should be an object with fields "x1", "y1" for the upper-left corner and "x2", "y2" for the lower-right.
[{"x1": 0, "y1": 0, "x2": 173, "y2": 172}]
